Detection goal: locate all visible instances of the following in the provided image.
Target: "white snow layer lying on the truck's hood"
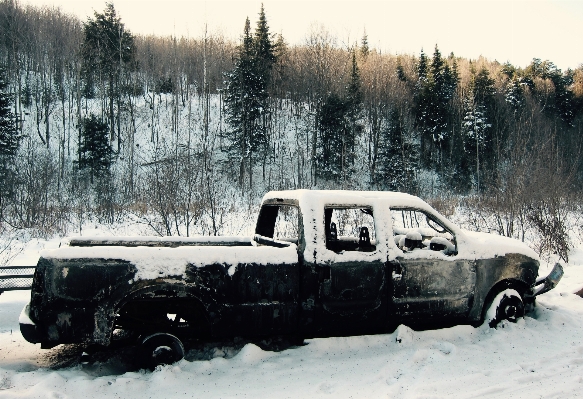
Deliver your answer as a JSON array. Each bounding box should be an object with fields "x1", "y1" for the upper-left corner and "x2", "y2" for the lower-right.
[{"x1": 456, "y1": 230, "x2": 539, "y2": 260}]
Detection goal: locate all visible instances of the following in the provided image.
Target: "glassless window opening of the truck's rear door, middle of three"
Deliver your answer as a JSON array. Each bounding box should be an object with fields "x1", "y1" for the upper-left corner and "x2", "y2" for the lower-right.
[{"x1": 324, "y1": 207, "x2": 376, "y2": 253}]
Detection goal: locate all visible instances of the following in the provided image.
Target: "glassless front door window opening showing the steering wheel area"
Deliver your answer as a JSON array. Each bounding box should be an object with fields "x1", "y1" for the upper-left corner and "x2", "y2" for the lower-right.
[{"x1": 391, "y1": 209, "x2": 456, "y2": 255}]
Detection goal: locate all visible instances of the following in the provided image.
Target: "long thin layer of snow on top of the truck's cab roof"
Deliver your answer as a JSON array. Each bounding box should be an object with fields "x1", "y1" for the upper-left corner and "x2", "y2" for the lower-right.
[{"x1": 263, "y1": 190, "x2": 435, "y2": 212}]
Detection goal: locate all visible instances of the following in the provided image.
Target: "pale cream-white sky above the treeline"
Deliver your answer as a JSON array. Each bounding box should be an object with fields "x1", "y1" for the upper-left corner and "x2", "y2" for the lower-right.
[{"x1": 21, "y1": 0, "x2": 583, "y2": 70}]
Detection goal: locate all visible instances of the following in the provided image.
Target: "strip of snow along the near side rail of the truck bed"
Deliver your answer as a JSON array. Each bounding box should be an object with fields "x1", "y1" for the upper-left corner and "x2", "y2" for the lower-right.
[{"x1": 40, "y1": 244, "x2": 298, "y2": 280}]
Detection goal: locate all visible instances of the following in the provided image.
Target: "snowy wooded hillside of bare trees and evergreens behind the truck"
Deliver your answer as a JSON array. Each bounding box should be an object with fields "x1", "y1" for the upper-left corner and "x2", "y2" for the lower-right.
[{"x1": 0, "y1": 0, "x2": 583, "y2": 261}]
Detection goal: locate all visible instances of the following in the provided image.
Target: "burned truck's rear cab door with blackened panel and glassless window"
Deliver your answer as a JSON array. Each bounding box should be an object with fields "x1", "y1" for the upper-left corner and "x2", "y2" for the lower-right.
[{"x1": 304, "y1": 207, "x2": 388, "y2": 335}]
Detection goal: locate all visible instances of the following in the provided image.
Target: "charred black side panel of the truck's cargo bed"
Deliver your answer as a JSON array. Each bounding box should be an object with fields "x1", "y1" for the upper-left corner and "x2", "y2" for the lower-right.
[{"x1": 29, "y1": 258, "x2": 299, "y2": 348}]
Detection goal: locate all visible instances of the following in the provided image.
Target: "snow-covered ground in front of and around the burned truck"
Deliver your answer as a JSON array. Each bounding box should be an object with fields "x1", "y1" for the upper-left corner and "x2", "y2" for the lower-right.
[{"x1": 0, "y1": 240, "x2": 583, "y2": 399}]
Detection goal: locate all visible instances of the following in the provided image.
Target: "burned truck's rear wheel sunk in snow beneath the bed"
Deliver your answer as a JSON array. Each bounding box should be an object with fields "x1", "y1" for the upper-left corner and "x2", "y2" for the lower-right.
[{"x1": 140, "y1": 333, "x2": 184, "y2": 369}]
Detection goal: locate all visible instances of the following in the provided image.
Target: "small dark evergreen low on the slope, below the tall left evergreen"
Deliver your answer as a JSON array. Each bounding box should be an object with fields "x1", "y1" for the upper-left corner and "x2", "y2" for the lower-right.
[{"x1": 78, "y1": 114, "x2": 113, "y2": 184}]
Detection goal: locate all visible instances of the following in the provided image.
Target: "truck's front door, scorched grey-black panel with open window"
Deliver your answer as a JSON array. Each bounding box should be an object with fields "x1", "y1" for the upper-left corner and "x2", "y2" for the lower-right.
[{"x1": 391, "y1": 209, "x2": 476, "y2": 320}]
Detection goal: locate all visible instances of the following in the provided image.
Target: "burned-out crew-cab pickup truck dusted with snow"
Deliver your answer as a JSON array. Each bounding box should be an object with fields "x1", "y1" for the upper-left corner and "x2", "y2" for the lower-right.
[{"x1": 20, "y1": 190, "x2": 562, "y2": 366}]
